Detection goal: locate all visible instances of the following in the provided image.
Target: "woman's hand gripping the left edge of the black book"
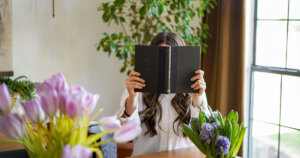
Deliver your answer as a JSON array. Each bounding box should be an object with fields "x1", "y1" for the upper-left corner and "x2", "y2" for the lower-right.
[{"x1": 126, "y1": 71, "x2": 146, "y2": 97}]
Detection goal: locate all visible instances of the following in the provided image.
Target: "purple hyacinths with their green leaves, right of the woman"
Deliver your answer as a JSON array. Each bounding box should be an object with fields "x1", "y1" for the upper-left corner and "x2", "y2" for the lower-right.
[{"x1": 181, "y1": 107, "x2": 246, "y2": 158}]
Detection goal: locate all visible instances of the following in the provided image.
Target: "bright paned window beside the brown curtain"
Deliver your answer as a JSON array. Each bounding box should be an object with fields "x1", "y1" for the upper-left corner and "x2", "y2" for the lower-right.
[{"x1": 248, "y1": 0, "x2": 300, "y2": 158}]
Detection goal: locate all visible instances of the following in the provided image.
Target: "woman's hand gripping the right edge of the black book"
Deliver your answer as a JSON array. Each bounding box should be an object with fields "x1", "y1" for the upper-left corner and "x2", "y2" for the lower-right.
[{"x1": 190, "y1": 70, "x2": 206, "y2": 105}]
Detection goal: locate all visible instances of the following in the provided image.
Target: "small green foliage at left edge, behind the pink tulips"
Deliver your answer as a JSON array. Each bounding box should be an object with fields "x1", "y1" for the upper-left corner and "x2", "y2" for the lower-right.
[{"x1": 0, "y1": 76, "x2": 36, "y2": 101}]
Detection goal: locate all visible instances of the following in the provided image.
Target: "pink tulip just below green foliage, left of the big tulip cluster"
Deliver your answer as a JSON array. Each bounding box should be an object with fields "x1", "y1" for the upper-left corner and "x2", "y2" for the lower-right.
[{"x1": 21, "y1": 98, "x2": 45, "y2": 123}]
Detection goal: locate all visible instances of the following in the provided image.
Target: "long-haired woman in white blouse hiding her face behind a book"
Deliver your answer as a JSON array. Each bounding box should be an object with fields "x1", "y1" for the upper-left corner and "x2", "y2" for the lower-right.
[{"x1": 118, "y1": 32, "x2": 208, "y2": 155}]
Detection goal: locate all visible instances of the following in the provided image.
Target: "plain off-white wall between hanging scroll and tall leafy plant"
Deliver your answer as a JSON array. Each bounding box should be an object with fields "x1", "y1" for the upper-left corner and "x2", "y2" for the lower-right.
[{"x1": 12, "y1": 0, "x2": 126, "y2": 116}]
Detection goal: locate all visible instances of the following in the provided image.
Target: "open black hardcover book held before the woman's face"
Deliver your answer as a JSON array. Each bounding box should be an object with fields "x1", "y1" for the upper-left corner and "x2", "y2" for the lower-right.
[{"x1": 135, "y1": 45, "x2": 200, "y2": 93}]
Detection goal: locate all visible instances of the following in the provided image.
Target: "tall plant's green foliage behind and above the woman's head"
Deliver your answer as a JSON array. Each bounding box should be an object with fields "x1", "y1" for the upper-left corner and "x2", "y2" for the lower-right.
[{"x1": 97, "y1": 0, "x2": 216, "y2": 73}]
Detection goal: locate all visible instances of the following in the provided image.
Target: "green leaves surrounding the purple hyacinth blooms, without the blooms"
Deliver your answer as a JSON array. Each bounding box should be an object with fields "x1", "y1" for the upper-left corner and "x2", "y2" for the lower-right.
[{"x1": 181, "y1": 108, "x2": 246, "y2": 158}]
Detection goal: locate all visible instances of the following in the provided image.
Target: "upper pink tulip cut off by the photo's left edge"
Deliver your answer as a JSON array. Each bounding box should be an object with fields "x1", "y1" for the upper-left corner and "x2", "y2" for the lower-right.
[{"x1": 0, "y1": 83, "x2": 12, "y2": 114}]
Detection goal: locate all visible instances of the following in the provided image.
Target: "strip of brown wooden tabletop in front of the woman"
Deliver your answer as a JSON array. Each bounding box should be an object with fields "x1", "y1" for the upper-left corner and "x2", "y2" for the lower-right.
[{"x1": 130, "y1": 147, "x2": 205, "y2": 158}]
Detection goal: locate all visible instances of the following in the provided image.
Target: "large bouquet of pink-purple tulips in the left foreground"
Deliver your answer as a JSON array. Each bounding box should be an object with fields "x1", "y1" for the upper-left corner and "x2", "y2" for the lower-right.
[{"x1": 0, "y1": 73, "x2": 141, "y2": 158}]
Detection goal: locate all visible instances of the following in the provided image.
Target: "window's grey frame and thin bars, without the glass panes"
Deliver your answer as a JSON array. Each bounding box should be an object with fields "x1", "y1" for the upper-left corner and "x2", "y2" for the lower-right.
[{"x1": 247, "y1": 0, "x2": 300, "y2": 158}]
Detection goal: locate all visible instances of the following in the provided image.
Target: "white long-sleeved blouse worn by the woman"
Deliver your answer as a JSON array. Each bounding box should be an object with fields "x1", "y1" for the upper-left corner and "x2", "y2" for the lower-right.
[{"x1": 117, "y1": 90, "x2": 208, "y2": 156}]
